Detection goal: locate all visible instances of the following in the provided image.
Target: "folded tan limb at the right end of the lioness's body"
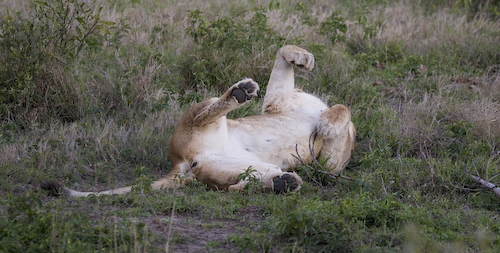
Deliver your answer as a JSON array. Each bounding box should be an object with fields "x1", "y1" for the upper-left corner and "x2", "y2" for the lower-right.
[{"x1": 316, "y1": 105, "x2": 356, "y2": 173}]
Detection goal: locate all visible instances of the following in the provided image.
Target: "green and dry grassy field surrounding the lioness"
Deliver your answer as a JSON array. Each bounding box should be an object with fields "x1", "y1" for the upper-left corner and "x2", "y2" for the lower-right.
[{"x1": 0, "y1": 0, "x2": 500, "y2": 252}]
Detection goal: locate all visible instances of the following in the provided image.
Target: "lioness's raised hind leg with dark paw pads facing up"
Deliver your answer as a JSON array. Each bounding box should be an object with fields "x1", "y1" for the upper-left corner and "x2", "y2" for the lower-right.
[{"x1": 194, "y1": 78, "x2": 259, "y2": 126}]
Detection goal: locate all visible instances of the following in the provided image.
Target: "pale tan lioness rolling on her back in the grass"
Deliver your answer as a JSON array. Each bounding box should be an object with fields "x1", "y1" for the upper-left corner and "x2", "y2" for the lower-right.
[{"x1": 50, "y1": 45, "x2": 356, "y2": 196}]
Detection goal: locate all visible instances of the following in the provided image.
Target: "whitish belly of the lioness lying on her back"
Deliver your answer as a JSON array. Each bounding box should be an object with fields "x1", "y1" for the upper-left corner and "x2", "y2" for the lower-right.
[{"x1": 222, "y1": 108, "x2": 321, "y2": 170}]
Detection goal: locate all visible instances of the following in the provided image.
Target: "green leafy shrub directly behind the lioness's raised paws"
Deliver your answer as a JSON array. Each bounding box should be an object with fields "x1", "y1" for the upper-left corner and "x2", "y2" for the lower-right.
[{"x1": 180, "y1": 10, "x2": 300, "y2": 93}]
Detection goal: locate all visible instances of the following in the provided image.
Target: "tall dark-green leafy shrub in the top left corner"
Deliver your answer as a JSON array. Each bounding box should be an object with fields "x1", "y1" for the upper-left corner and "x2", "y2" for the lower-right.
[{"x1": 0, "y1": 0, "x2": 113, "y2": 126}]
